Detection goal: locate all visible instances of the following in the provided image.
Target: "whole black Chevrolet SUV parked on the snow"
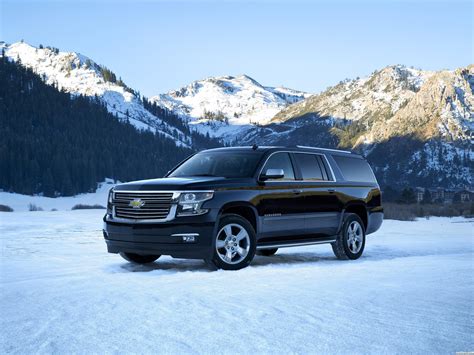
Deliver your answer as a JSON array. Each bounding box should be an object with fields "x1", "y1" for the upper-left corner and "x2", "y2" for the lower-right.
[{"x1": 104, "y1": 146, "x2": 383, "y2": 270}]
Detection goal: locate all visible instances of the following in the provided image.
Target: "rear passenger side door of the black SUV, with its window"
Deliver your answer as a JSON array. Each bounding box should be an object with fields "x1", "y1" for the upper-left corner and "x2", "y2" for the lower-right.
[{"x1": 293, "y1": 152, "x2": 342, "y2": 237}]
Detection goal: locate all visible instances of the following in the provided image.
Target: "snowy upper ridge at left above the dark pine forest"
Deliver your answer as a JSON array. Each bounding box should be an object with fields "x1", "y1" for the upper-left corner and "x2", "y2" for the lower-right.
[{"x1": 2, "y1": 42, "x2": 192, "y2": 146}]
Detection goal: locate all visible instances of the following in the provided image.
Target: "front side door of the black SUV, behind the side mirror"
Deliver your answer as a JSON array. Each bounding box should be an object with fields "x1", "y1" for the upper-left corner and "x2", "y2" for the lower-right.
[{"x1": 256, "y1": 152, "x2": 305, "y2": 237}]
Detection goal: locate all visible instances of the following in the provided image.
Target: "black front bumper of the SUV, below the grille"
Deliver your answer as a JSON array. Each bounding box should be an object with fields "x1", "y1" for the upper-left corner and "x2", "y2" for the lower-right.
[{"x1": 103, "y1": 209, "x2": 218, "y2": 259}]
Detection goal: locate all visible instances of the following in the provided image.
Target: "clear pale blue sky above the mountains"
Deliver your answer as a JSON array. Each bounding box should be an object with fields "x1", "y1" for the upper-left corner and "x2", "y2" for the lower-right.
[{"x1": 0, "y1": 0, "x2": 474, "y2": 96}]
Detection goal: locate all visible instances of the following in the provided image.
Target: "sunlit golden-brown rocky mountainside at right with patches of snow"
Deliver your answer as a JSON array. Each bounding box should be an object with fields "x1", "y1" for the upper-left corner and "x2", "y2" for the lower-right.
[{"x1": 272, "y1": 65, "x2": 474, "y2": 147}]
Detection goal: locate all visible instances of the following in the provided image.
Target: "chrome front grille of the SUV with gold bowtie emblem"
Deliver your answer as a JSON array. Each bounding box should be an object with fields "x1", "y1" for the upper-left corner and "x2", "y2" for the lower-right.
[{"x1": 112, "y1": 191, "x2": 175, "y2": 220}]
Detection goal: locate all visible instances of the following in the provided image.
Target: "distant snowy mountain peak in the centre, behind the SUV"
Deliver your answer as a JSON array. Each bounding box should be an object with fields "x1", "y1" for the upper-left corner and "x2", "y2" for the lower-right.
[{"x1": 150, "y1": 75, "x2": 310, "y2": 136}]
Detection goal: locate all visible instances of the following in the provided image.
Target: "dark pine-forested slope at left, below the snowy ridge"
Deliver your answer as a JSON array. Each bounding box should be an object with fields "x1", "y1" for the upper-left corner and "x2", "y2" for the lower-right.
[{"x1": 0, "y1": 60, "x2": 192, "y2": 196}]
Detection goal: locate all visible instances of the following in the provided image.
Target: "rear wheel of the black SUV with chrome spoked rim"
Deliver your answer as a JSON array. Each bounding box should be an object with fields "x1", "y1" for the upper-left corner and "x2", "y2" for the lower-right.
[{"x1": 331, "y1": 213, "x2": 365, "y2": 260}]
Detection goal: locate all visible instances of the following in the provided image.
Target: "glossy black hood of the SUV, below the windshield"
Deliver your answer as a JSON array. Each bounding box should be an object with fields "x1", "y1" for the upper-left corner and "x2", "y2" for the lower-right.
[{"x1": 115, "y1": 176, "x2": 254, "y2": 191}]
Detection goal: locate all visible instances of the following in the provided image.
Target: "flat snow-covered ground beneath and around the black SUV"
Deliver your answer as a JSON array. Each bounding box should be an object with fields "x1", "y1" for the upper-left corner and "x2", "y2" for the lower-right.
[{"x1": 0, "y1": 210, "x2": 474, "y2": 354}]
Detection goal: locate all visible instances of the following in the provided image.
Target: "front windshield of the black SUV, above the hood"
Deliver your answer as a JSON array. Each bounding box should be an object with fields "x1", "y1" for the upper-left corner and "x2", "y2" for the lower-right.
[{"x1": 168, "y1": 151, "x2": 262, "y2": 178}]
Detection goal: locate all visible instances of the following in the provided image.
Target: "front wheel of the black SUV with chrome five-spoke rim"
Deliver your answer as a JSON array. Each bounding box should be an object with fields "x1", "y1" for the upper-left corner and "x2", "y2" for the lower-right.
[{"x1": 210, "y1": 214, "x2": 257, "y2": 270}]
